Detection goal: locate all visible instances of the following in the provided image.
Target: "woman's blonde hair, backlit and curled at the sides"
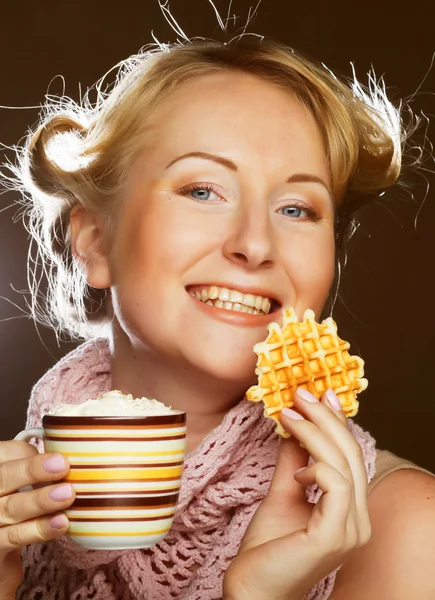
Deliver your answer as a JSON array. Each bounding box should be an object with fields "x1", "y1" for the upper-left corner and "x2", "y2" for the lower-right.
[{"x1": 5, "y1": 38, "x2": 406, "y2": 338}]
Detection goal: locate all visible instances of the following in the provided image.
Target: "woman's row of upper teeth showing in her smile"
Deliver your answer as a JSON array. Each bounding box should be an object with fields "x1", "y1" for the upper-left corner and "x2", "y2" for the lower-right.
[{"x1": 191, "y1": 285, "x2": 271, "y2": 315}]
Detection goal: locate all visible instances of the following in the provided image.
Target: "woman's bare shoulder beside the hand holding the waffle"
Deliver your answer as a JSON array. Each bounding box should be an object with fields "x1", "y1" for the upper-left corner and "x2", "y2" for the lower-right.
[{"x1": 331, "y1": 468, "x2": 435, "y2": 600}]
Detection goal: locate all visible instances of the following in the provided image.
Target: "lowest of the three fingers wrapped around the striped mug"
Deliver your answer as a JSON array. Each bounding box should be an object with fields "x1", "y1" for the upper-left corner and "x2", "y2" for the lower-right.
[{"x1": 0, "y1": 513, "x2": 69, "y2": 556}]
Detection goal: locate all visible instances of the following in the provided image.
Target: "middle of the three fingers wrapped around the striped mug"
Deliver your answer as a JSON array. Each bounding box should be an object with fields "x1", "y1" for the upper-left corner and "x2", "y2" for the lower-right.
[{"x1": 0, "y1": 483, "x2": 75, "y2": 527}]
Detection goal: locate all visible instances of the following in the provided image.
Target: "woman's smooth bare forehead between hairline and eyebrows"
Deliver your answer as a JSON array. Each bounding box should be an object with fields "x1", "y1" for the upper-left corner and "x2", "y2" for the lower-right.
[{"x1": 145, "y1": 71, "x2": 326, "y2": 171}]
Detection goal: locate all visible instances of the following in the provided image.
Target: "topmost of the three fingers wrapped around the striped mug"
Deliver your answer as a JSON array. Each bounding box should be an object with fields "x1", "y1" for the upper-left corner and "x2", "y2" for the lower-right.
[{"x1": 0, "y1": 454, "x2": 69, "y2": 497}]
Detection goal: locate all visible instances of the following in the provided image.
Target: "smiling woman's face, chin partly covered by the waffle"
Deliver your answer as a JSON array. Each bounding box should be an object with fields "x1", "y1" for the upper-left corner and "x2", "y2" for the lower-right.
[{"x1": 104, "y1": 73, "x2": 334, "y2": 381}]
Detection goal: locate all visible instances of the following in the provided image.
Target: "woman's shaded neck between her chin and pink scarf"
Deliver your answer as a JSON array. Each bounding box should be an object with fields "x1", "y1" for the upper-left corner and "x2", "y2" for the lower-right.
[{"x1": 111, "y1": 334, "x2": 252, "y2": 452}]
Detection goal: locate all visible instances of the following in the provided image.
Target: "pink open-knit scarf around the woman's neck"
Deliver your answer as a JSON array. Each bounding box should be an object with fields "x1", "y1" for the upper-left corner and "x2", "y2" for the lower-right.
[{"x1": 17, "y1": 341, "x2": 376, "y2": 600}]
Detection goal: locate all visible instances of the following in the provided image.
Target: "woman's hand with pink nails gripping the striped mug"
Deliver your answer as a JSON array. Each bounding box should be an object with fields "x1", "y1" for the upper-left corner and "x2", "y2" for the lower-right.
[{"x1": 0, "y1": 440, "x2": 75, "y2": 598}]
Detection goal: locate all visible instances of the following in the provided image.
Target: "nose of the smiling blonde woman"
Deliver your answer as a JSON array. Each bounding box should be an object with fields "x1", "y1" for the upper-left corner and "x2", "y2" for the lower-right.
[{"x1": 223, "y1": 200, "x2": 275, "y2": 270}]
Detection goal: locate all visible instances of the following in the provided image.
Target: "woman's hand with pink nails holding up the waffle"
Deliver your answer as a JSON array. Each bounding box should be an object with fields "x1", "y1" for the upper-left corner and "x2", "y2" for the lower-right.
[{"x1": 224, "y1": 389, "x2": 371, "y2": 600}]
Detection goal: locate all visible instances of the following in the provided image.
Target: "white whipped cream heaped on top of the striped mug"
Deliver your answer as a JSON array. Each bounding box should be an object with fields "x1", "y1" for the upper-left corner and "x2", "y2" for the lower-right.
[{"x1": 48, "y1": 390, "x2": 174, "y2": 417}]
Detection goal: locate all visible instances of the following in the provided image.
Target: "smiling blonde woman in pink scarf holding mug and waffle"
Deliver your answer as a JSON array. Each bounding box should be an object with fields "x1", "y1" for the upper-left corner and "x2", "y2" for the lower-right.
[{"x1": 0, "y1": 40, "x2": 435, "y2": 600}]
